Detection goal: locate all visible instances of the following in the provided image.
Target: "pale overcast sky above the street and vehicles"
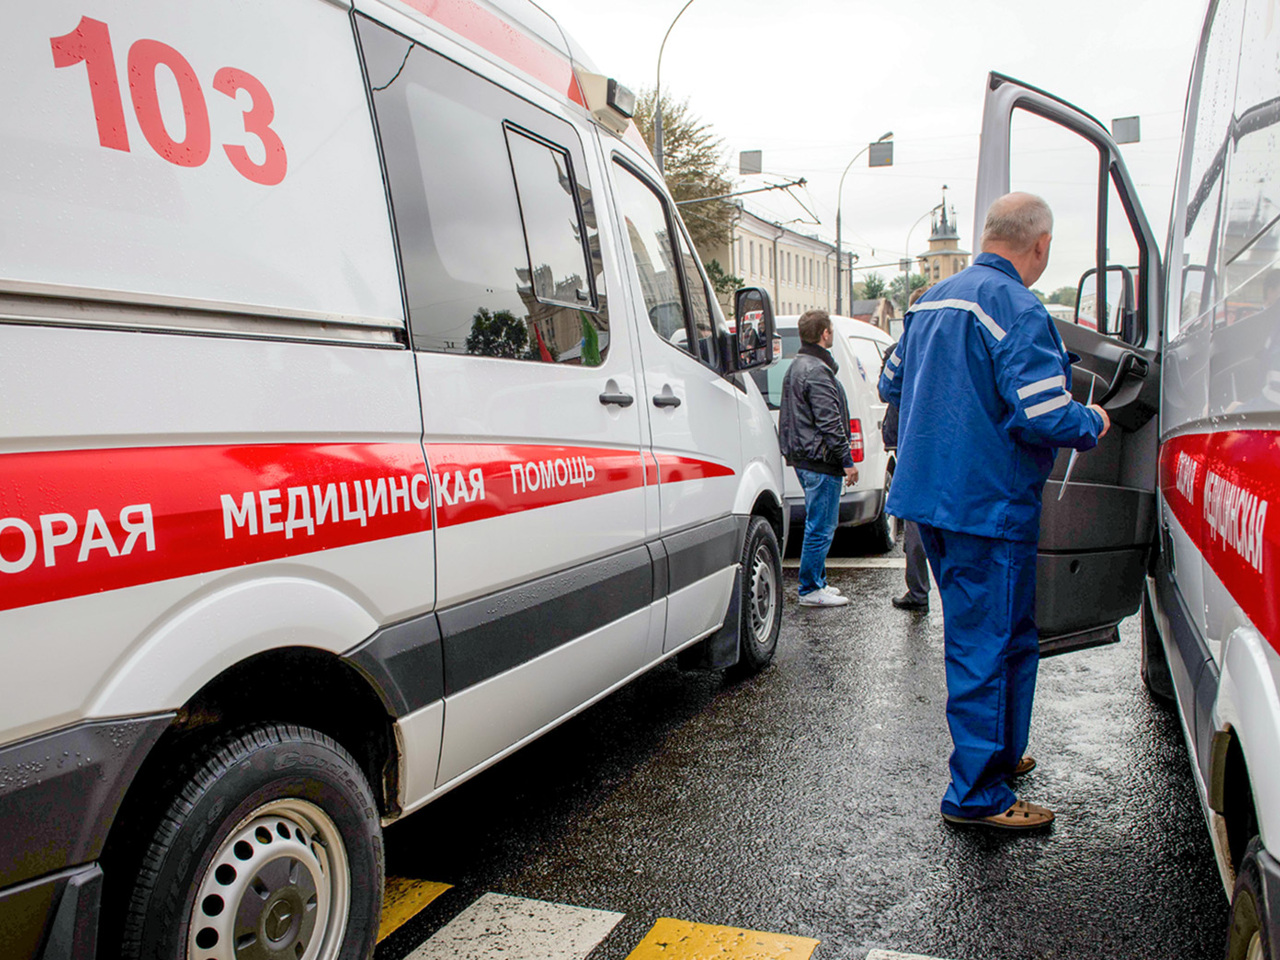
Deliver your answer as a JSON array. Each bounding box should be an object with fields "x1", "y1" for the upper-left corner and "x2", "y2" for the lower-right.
[{"x1": 538, "y1": 0, "x2": 1206, "y2": 291}]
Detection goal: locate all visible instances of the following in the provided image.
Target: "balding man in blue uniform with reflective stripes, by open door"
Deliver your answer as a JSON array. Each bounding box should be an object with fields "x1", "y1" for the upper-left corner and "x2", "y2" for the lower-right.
[{"x1": 879, "y1": 193, "x2": 1110, "y2": 829}]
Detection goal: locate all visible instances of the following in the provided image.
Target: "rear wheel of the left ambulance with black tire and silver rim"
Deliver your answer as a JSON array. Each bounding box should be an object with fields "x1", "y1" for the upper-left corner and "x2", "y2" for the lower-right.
[{"x1": 119, "y1": 723, "x2": 383, "y2": 960}]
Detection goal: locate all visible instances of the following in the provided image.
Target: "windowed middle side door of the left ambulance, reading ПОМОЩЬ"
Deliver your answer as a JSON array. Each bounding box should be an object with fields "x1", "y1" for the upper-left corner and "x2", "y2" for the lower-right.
[{"x1": 358, "y1": 18, "x2": 653, "y2": 786}]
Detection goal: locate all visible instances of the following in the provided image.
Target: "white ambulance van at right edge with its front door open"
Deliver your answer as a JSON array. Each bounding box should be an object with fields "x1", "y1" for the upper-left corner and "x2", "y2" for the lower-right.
[{"x1": 975, "y1": 0, "x2": 1280, "y2": 960}]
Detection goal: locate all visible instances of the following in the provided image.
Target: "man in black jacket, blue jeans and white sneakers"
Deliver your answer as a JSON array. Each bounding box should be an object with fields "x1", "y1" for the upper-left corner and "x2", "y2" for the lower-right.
[{"x1": 778, "y1": 310, "x2": 858, "y2": 607}]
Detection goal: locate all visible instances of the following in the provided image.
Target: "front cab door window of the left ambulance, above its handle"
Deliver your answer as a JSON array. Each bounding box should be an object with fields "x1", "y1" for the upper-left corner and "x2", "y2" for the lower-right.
[{"x1": 613, "y1": 164, "x2": 694, "y2": 353}]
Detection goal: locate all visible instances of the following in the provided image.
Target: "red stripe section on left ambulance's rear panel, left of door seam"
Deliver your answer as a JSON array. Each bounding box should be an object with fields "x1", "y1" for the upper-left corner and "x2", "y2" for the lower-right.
[{"x1": 0, "y1": 443, "x2": 431, "y2": 609}]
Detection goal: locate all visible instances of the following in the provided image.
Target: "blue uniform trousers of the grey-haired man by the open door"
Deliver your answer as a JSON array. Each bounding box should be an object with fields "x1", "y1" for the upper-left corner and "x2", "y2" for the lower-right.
[{"x1": 919, "y1": 524, "x2": 1039, "y2": 817}]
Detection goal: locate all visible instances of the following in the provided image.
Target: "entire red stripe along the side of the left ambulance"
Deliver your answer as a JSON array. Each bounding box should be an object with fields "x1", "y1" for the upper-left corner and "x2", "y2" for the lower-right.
[{"x1": 0, "y1": 443, "x2": 733, "y2": 611}]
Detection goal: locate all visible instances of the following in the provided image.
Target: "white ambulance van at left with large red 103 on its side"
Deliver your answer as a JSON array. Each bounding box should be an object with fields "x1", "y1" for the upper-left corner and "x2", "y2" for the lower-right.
[{"x1": 0, "y1": 0, "x2": 786, "y2": 960}]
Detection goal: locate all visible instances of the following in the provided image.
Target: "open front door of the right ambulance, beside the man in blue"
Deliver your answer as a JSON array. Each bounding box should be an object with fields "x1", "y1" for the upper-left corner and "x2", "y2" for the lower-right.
[{"x1": 974, "y1": 73, "x2": 1162, "y2": 654}]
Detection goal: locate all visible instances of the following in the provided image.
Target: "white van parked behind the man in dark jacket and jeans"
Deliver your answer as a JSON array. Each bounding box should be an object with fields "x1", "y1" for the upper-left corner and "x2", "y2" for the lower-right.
[{"x1": 751, "y1": 315, "x2": 896, "y2": 553}]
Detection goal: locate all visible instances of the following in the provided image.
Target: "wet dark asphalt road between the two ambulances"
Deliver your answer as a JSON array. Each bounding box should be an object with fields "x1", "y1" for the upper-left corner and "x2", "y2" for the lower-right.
[{"x1": 378, "y1": 537, "x2": 1228, "y2": 960}]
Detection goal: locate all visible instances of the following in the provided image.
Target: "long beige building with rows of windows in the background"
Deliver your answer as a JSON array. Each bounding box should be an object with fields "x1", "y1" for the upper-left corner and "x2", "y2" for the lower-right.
[{"x1": 701, "y1": 206, "x2": 850, "y2": 315}]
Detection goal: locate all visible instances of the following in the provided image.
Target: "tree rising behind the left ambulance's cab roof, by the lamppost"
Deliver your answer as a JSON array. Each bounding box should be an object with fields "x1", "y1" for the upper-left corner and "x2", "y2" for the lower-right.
[{"x1": 635, "y1": 90, "x2": 733, "y2": 252}]
